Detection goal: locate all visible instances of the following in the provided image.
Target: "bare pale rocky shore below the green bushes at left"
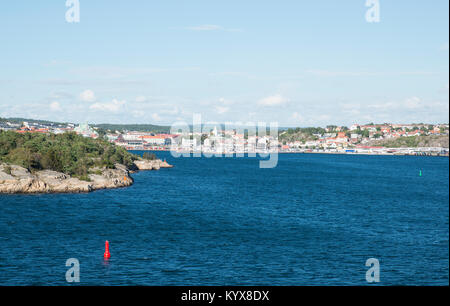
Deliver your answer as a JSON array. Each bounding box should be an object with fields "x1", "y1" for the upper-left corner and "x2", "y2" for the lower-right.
[{"x1": 0, "y1": 159, "x2": 173, "y2": 194}]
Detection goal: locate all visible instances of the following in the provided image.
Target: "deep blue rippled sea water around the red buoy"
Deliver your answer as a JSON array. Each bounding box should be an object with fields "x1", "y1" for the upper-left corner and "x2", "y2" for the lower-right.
[{"x1": 0, "y1": 152, "x2": 449, "y2": 285}]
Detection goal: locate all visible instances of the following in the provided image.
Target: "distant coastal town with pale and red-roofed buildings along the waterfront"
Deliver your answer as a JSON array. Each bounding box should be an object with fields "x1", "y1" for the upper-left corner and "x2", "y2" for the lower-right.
[{"x1": 0, "y1": 118, "x2": 449, "y2": 160}]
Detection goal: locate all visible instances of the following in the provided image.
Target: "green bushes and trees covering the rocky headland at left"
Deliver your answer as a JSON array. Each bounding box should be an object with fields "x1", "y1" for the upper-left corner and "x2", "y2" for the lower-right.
[{"x1": 0, "y1": 131, "x2": 138, "y2": 178}]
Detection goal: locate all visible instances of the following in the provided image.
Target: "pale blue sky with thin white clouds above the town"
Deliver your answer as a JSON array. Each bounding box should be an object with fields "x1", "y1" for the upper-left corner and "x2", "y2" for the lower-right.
[{"x1": 0, "y1": 0, "x2": 449, "y2": 127}]
